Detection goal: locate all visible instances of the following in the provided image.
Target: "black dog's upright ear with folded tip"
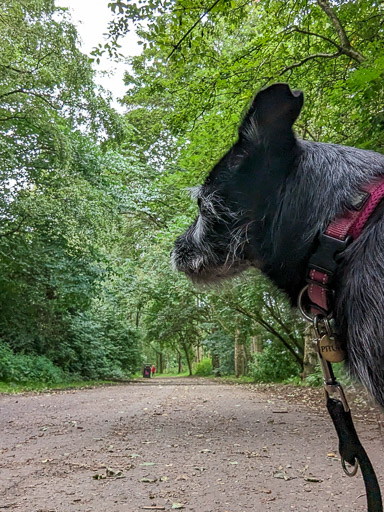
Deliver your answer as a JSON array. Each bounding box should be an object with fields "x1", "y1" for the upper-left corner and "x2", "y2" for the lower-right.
[{"x1": 239, "y1": 84, "x2": 304, "y2": 139}]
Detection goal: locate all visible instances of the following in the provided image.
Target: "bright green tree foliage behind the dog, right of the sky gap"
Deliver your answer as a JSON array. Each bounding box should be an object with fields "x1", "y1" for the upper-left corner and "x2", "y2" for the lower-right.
[{"x1": 99, "y1": 0, "x2": 384, "y2": 386}]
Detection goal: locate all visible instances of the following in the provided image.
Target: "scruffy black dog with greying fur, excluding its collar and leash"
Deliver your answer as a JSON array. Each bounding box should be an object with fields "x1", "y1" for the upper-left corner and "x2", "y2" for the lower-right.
[{"x1": 172, "y1": 84, "x2": 384, "y2": 406}]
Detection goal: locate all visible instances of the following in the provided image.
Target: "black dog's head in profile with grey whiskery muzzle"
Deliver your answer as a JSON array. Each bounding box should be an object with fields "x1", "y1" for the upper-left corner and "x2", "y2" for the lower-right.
[{"x1": 172, "y1": 84, "x2": 303, "y2": 283}]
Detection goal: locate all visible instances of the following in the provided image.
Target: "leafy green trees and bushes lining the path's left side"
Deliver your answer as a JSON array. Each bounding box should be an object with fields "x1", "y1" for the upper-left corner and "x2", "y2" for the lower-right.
[{"x1": 0, "y1": 0, "x2": 139, "y2": 382}]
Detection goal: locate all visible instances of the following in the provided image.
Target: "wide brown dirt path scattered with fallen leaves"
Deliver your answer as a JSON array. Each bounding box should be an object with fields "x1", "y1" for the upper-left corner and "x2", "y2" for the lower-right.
[{"x1": 0, "y1": 379, "x2": 384, "y2": 512}]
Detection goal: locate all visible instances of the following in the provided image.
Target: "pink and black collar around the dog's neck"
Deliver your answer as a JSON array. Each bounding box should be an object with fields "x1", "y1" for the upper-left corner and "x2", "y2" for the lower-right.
[{"x1": 307, "y1": 177, "x2": 384, "y2": 316}]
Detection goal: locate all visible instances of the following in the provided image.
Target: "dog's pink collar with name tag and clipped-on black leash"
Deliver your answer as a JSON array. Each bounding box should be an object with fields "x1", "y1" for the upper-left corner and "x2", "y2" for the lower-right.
[{"x1": 299, "y1": 177, "x2": 384, "y2": 512}]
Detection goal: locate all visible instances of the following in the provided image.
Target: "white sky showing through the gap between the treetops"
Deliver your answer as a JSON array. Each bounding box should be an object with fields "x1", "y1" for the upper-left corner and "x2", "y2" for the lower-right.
[{"x1": 56, "y1": 0, "x2": 141, "y2": 112}]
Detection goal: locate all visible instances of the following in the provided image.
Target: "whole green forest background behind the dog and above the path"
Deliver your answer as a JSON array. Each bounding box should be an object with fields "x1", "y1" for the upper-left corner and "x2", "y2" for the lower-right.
[{"x1": 0, "y1": 0, "x2": 384, "y2": 389}]
